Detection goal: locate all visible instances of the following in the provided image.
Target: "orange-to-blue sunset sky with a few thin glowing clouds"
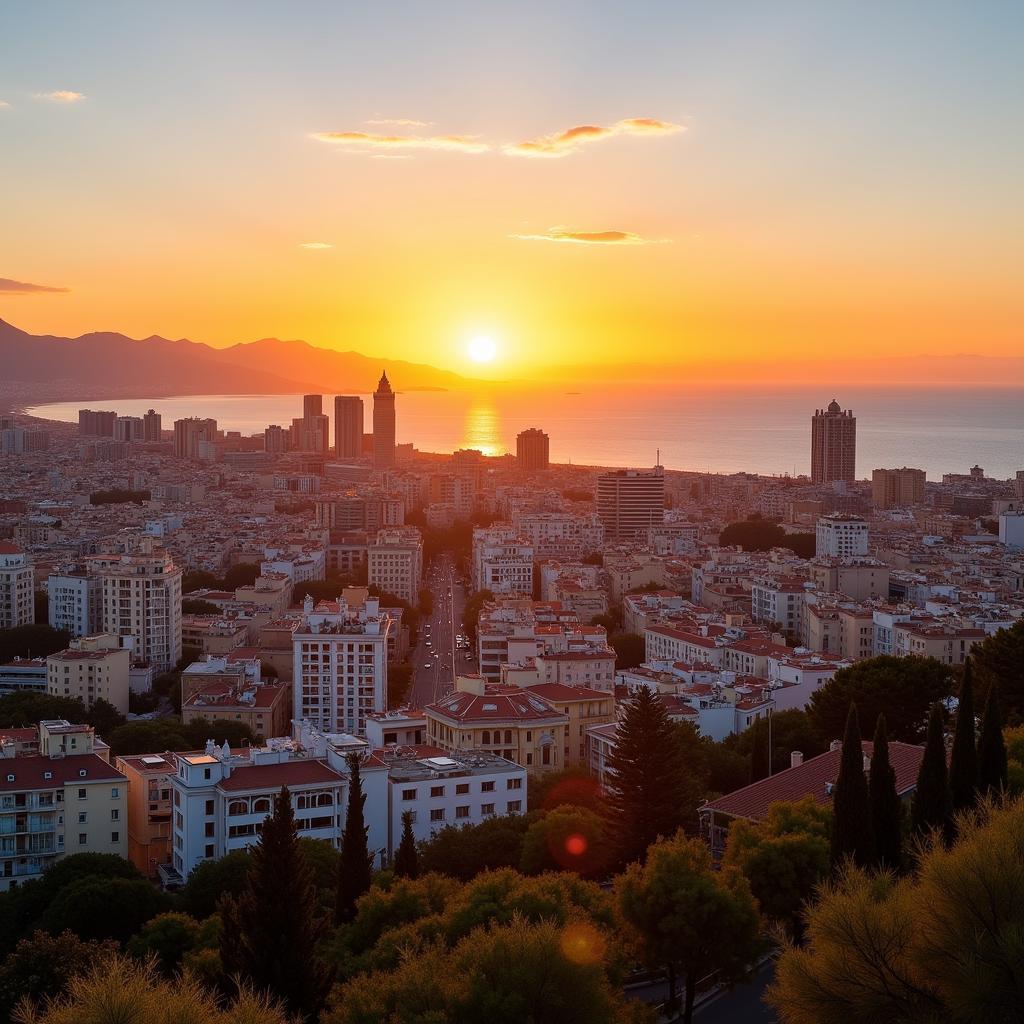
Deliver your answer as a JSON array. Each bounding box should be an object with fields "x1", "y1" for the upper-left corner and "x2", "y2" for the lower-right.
[{"x1": 0, "y1": 0, "x2": 1024, "y2": 378}]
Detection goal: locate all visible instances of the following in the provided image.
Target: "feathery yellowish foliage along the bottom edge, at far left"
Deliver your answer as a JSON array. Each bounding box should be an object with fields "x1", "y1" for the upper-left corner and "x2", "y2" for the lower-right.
[{"x1": 17, "y1": 952, "x2": 288, "y2": 1024}]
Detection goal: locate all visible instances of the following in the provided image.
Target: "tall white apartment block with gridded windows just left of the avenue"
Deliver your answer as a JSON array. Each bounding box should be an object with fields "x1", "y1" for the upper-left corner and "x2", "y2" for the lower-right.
[{"x1": 292, "y1": 597, "x2": 397, "y2": 735}]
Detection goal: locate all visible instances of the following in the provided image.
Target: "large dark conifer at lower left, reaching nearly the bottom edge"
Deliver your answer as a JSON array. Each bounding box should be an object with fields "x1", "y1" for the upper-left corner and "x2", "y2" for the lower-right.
[{"x1": 218, "y1": 787, "x2": 331, "y2": 1021}]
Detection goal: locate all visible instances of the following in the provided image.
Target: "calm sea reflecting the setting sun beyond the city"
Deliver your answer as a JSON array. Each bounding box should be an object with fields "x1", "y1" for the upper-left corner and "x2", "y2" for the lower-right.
[{"x1": 28, "y1": 384, "x2": 1024, "y2": 480}]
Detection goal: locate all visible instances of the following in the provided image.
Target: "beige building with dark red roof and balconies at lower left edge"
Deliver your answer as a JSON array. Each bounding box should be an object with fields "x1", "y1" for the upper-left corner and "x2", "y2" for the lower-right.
[{"x1": 0, "y1": 720, "x2": 128, "y2": 892}]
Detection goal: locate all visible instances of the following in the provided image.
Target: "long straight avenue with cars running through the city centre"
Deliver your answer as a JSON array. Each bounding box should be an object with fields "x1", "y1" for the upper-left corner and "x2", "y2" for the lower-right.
[{"x1": 409, "y1": 555, "x2": 475, "y2": 708}]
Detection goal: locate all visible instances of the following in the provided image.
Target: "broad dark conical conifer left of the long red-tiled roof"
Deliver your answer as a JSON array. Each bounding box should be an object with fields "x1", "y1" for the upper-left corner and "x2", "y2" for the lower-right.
[{"x1": 605, "y1": 686, "x2": 702, "y2": 863}]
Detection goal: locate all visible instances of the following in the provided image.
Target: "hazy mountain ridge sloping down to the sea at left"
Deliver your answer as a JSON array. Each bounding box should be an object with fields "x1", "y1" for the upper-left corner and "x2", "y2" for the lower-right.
[{"x1": 0, "y1": 319, "x2": 472, "y2": 398}]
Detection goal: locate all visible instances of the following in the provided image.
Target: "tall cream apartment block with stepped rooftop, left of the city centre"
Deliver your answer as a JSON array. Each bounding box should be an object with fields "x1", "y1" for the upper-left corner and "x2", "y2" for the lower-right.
[{"x1": 87, "y1": 538, "x2": 181, "y2": 673}]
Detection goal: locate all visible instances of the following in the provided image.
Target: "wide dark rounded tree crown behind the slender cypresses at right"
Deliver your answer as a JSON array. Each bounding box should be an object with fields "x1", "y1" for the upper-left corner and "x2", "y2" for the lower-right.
[{"x1": 807, "y1": 654, "x2": 952, "y2": 743}]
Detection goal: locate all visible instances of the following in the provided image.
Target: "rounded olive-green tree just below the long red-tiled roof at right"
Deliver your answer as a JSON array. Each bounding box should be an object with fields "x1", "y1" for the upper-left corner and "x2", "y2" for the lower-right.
[{"x1": 722, "y1": 797, "x2": 831, "y2": 941}]
